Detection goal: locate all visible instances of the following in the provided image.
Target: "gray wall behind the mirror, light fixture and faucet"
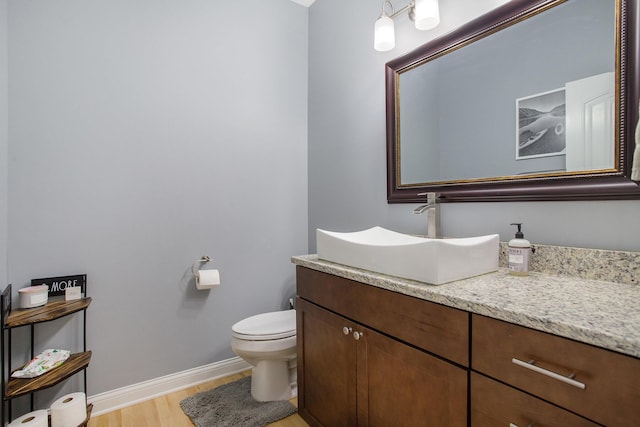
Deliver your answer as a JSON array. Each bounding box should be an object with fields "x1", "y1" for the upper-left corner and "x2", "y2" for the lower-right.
[{"x1": 309, "y1": 0, "x2": 640, "y2": 252}]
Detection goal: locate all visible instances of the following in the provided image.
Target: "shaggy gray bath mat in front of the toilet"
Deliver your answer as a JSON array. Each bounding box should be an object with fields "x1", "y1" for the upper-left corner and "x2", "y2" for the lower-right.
[{"x1": 180, "y1": 377, "x2": 296, "y2": 427}]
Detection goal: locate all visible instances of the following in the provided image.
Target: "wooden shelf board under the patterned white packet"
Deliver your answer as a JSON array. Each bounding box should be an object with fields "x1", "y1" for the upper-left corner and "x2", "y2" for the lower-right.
[{"x1": 4, "y1": 351, "x2": 91, "y2": 400}]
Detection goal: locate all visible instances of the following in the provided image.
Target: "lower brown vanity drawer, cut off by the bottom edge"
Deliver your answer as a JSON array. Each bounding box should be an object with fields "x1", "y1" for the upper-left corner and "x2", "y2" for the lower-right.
[{"x1": 471, "y1": 372, "x2": 599, "y2": 427}]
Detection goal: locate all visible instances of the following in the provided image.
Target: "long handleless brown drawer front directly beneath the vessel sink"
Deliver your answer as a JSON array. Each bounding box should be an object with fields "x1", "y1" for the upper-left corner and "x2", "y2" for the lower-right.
[{"x1": 296, "y1": 266, "x2": 469, "y2": 366}]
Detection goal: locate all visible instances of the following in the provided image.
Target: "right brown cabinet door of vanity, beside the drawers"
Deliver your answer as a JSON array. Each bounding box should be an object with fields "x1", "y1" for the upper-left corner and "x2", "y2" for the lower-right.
[{"x1": 357, "y1": 327, "x2": 467, "y2": 427}]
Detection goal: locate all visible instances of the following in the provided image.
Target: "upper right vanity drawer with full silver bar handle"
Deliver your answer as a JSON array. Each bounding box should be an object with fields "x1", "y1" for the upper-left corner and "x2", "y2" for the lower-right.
[{"x1": 471, "y1": 314, "x2": 640, "y2": 426}]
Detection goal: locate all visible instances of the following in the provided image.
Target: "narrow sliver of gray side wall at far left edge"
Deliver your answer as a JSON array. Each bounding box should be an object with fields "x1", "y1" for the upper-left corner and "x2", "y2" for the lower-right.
[{"x1": 0, "y1": 0, "x2": 9, "y2": 286}]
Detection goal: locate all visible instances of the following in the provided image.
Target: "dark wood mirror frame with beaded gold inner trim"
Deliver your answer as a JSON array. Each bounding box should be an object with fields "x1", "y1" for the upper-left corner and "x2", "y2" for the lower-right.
[{"x1": 385, "y1": 0, "x2": 640, "y2": 203}]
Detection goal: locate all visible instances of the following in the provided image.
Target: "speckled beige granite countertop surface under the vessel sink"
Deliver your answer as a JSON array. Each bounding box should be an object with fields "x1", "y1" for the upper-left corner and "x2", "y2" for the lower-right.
[{"x1": 292, "y1": 255, "x2": 640, "y2": 357}]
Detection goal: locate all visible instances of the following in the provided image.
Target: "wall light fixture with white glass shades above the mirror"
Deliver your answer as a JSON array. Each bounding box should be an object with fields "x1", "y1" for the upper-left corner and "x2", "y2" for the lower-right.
[{"x1": 373, "y1": 0, "x2": 440, "y2": 52}]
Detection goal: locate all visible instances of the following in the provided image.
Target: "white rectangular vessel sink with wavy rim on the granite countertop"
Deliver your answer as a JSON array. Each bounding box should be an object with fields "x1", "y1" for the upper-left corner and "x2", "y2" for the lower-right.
[{"x1": 316, "y1": 227, "x2": 499, "y2": 285}]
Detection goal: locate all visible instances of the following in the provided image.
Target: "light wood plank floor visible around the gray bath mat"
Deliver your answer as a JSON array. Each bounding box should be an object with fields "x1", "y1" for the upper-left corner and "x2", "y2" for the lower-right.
[{"x1": 88, "y1": 371, "x2": 308, "y2": 427}]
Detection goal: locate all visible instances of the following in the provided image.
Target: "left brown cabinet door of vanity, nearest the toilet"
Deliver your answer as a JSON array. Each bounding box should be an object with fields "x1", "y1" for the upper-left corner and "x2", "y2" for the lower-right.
[{"x1": 296, "y1": 298, "x2": 357, "y2": 427}]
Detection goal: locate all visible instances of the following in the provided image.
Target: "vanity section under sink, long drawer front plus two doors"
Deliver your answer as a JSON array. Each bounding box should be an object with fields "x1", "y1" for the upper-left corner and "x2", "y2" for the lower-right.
[{"x1": 296, "y1": 267, "x2": 469, "y2": 427}]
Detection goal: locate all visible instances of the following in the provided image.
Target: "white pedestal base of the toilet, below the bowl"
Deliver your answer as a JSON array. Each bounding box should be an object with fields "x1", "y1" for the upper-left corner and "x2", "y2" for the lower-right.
[{"x1": 251, "y1": 360, "x2": 297, "y2": 402}]
